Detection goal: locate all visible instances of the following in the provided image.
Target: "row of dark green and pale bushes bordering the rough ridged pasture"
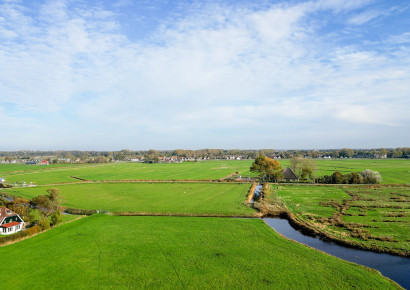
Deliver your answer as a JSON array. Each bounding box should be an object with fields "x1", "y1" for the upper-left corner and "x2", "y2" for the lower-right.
[{"x1": 315, "y1": 169, "x2": 383, "y2": 184}]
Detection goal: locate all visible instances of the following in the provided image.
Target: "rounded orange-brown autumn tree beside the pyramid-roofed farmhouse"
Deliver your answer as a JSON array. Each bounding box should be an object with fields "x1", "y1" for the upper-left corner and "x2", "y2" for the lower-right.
[{"x1": 250, "y1": 155, "x2": 283, "y2": 182}]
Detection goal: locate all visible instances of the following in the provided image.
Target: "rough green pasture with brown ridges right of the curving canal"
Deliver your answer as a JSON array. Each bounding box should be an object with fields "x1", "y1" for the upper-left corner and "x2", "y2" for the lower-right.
[{"x1": 272, "y1": 185, "x2": 410, "y2": 255}]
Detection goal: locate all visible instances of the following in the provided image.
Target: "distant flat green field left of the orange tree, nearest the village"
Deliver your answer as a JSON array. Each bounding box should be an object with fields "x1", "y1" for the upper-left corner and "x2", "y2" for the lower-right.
[{"x1": 0, "y1": 160, "x2": 254, "y2": 184}]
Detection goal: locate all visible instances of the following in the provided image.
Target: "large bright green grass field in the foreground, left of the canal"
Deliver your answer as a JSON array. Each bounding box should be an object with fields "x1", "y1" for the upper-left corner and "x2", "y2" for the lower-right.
[{"x1": 0, "y1": 215, "x2": 398, "y2": 289}]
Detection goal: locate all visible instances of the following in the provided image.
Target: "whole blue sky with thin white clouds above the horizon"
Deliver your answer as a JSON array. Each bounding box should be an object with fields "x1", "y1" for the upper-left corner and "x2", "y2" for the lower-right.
[{"x1": 0, "y1": 0, "x2": 410, "y2": 150}]
